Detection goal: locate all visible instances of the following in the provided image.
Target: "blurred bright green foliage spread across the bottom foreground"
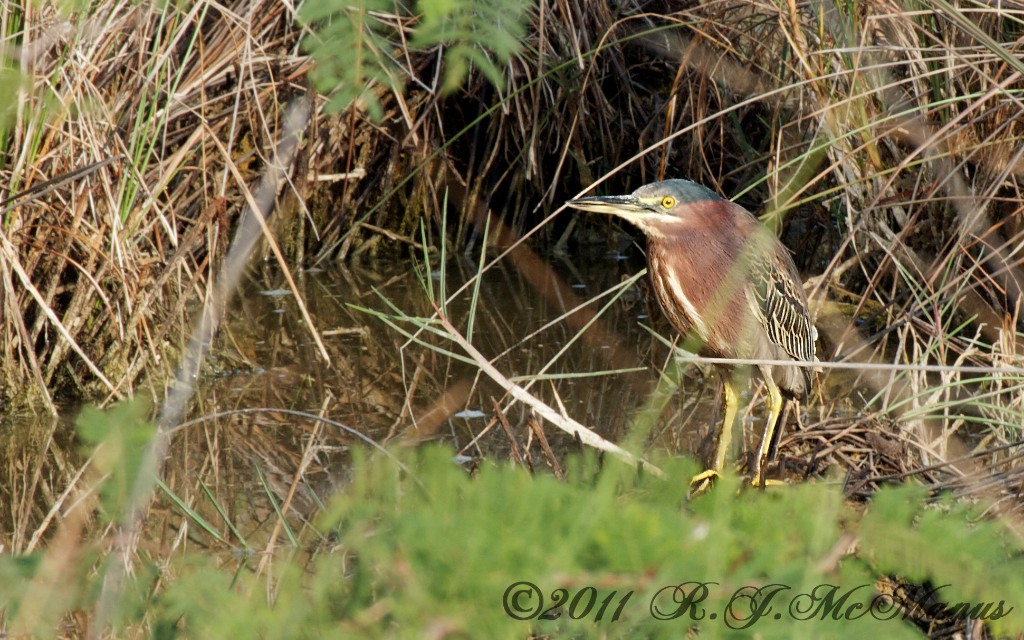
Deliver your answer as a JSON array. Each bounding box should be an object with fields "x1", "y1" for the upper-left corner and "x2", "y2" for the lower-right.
[{"x1": 0, "y1": 403, "x2": 1024, "y2": 638}]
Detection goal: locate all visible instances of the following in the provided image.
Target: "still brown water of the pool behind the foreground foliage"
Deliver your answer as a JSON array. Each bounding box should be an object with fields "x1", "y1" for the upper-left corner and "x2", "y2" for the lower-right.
[{"x1": 0, "y1": 246, "x2": 782, "y2": 549}]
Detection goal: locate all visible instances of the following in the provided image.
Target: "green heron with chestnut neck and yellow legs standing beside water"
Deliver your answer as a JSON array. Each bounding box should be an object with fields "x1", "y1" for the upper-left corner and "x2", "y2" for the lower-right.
[{"x1": 566, "y1": 180, "x2": 817, "y2": 486}]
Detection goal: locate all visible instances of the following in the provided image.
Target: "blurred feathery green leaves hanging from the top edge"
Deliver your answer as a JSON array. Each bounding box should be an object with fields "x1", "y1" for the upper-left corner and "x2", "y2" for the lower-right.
[{"x1": 300, "y1": 0, "x2": 532, "y2": 120}]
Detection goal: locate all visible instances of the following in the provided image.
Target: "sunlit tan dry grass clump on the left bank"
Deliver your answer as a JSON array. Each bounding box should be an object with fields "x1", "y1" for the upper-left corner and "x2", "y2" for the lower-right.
[{"x1": 0, "y1": 2, "x2": 308, "y2": 402}]
